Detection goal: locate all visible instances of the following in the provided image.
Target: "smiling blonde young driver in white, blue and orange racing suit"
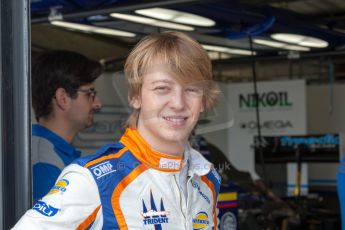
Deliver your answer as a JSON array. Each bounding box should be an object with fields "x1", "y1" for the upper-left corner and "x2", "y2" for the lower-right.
[{"x1": 15, "y1": 32, "x2": 220, "y2": 230}]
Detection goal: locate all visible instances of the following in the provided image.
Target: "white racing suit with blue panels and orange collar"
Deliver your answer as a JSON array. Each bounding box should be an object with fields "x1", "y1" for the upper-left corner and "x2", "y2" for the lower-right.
[{"x1": 14, "y1": 129, "x2": 220, "y2": 230}]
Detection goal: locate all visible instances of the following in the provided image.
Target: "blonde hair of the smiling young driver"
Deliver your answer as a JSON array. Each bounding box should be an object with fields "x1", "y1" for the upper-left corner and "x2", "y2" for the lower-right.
[{"x1": 124, "y1": 31, "x2": 220, "y2": 128}]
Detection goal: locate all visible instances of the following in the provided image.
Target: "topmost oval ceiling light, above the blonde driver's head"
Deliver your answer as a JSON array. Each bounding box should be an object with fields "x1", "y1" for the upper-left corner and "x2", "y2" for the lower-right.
[{"x1": 135, "y1": 8, "x2": 216, "y2": 27}]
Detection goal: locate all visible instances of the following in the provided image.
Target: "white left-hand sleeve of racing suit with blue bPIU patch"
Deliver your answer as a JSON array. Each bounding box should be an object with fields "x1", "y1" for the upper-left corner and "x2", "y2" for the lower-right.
[{"x1": 13, "y1": 164, "x2": 102, "y2": 230}]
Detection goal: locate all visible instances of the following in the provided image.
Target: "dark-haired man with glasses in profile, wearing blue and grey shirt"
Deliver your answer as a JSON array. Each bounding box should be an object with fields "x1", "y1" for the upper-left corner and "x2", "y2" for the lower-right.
[{"x1": 32, "y1": 50, "x2": 102, "y2": 201}]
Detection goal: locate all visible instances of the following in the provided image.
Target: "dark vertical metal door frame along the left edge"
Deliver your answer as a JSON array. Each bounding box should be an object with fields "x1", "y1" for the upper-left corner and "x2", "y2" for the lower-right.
[{"x1": 0, "y1": 0, "x2": 31, "y2": 229}]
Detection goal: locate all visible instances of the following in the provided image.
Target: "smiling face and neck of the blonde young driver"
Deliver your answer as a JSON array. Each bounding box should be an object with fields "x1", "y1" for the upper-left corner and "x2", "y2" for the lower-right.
[{"x1": 132, "y1": 68, "x2": 204, "y2": 155}]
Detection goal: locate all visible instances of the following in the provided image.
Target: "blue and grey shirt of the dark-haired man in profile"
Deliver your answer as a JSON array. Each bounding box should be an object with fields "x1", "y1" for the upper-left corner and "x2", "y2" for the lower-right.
[{"x1": 31, "y1": 124, "x2": 81, "y2": 201}]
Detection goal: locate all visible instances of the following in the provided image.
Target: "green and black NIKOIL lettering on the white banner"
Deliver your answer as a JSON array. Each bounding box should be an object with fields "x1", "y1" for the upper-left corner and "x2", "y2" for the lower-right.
[{"x1": 239, "y1": 91, "x2": 292, "y2": 109}]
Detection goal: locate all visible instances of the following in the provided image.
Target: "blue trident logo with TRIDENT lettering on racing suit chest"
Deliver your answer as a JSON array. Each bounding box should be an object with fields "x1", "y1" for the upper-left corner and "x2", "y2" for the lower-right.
[{"x1": 141, "y1": 191, "x2": 170, "y2": 230}]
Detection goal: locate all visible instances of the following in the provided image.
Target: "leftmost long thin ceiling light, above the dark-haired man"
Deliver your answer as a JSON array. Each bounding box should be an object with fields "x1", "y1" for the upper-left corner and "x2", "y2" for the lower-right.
[{"x1": 50, "y1": 21, "x2": 136, "y2": 37}]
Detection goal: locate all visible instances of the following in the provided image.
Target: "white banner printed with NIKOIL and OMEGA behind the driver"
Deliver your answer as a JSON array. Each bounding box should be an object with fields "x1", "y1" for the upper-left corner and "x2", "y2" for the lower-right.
[{"x1": 228, "y1": 80, "x2": 307, "y2": 179}]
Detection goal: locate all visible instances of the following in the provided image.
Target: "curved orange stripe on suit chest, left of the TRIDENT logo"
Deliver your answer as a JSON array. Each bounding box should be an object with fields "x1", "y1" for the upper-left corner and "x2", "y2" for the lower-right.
[{"x1": 111, "y1": 164, "x2": 147, "y2": 230}]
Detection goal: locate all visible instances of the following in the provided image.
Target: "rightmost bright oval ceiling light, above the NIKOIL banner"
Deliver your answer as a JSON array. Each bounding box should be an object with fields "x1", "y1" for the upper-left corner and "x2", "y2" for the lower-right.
[{"x1": 271, "y1": 33, "x2": 328, "y2": 48}]
